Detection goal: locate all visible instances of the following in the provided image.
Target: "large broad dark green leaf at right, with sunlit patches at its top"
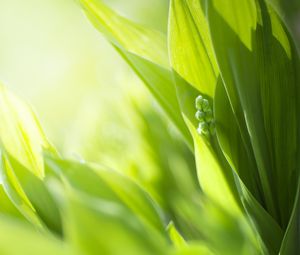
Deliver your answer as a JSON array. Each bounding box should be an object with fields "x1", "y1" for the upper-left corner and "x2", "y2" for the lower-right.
[{"x1": 207, "y1": 0, "x2": 299, "y2": 226}]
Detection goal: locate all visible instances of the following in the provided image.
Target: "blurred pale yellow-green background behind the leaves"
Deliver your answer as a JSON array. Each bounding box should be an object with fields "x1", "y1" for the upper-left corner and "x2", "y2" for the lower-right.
[{"x1": 0, "y1": 0, "x2": 197, "y2": 211}]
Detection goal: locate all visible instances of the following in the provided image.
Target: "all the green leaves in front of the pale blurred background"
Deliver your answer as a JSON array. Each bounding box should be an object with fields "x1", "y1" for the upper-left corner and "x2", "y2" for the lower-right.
[{"x1": 0, "y1": 0, "x2": 300, "y2": 255}]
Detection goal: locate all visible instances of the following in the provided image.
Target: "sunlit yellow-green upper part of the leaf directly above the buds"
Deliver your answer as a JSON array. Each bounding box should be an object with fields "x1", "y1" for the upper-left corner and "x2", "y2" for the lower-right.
[{"x1": 169, "y1": 0, "x2": 219, "y2": 98}]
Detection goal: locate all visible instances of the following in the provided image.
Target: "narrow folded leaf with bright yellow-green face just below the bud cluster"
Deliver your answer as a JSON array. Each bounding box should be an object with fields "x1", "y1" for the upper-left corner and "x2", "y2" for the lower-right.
[{"x1": 172, "y1": 77, "x2": 268, "y2": 250}]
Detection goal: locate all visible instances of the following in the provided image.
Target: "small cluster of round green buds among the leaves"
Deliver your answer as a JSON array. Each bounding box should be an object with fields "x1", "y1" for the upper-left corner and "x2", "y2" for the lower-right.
[{"x1": 195, "y1": 95, "x2": 216, "y2": 136}]
